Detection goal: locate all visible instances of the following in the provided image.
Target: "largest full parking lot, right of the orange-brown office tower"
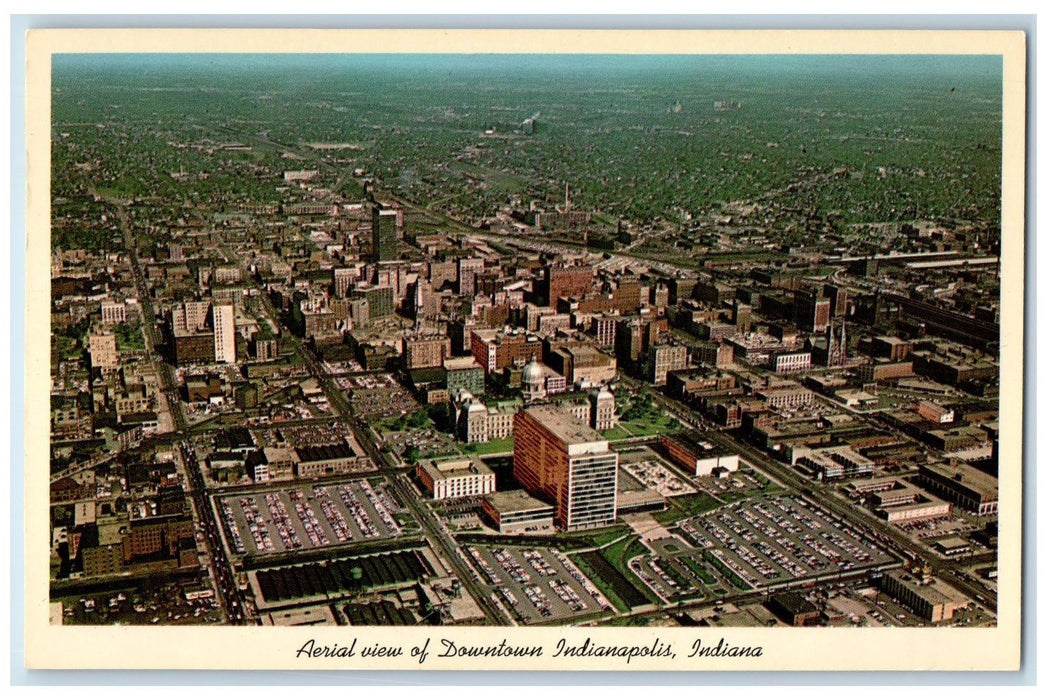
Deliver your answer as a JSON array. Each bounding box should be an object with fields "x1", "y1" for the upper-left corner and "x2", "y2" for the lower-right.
[{"x1": 681, "y1": 495, "x2": 894, "y2": 588}]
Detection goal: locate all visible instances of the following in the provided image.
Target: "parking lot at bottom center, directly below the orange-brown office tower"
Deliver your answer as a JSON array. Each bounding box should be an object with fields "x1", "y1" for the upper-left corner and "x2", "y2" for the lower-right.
[{"x1": 464, "y1": 545, "x2": 614, "y2": 625}]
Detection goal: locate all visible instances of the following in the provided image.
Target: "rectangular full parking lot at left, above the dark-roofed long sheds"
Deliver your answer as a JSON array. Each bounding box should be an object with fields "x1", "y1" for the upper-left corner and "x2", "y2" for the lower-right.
[{"x1": 217, "y1": 479, "x2": 401, "y2": 555}]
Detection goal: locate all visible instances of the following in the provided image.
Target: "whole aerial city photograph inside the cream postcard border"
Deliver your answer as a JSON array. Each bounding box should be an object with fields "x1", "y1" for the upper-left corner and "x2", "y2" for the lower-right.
[{"x1": 51, "y1": 53, "x2": 1016, "y2": 628}]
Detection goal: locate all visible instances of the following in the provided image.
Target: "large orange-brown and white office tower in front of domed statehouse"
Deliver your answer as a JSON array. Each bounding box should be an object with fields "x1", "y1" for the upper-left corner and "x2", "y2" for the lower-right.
[{"x1": 513, "y1": 406, "x2": 618, "y2": 529}]
